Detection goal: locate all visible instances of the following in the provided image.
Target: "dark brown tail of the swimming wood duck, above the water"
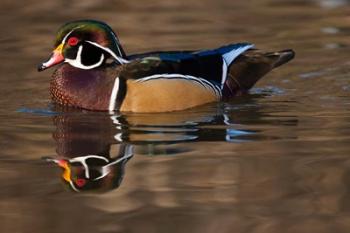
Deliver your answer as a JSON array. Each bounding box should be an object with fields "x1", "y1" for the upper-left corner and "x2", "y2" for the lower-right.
[{"x1": 223, "y1": 49, "x2": 295, "y2": 99}]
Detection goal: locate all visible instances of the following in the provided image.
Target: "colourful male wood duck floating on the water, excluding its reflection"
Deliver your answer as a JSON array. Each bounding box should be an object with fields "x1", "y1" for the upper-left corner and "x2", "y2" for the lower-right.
[{"x1": 38, "y1": 20, "x2": 294, "y2": 112}]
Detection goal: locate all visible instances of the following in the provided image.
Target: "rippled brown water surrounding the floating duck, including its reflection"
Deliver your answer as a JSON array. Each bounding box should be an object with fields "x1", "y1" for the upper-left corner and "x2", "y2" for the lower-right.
[{"x1": 0, "y1": 0, "x2": 350, "y2": 233}]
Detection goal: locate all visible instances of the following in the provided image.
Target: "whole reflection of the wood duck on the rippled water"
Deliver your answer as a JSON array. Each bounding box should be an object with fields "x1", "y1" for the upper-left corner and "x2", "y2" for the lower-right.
[{"x1": 46, "y1": 100, "x2": 292, "y2": 192}]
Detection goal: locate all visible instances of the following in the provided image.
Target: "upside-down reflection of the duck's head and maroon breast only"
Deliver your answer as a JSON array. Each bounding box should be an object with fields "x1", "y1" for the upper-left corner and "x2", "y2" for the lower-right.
[{"x1": 45, "y1": 112, "x2": 133, "y2": 192}]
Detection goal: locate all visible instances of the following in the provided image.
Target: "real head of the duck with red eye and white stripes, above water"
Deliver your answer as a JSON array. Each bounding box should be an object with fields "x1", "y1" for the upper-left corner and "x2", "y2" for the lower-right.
[{"x1": 38, "y1": 20, "x2": 127, "y2": 71}]
